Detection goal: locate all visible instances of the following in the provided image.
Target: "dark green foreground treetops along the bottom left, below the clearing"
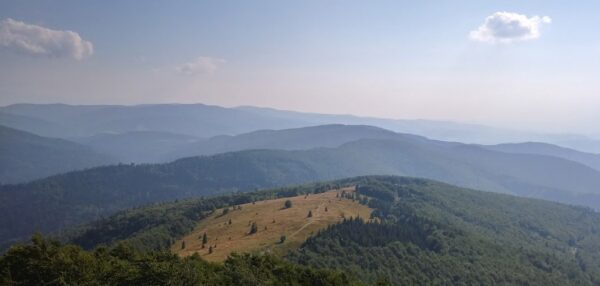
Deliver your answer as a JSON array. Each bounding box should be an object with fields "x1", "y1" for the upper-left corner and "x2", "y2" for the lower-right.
[{"x1": 0, "y1": 235, "x2": 359, "y2": 285}]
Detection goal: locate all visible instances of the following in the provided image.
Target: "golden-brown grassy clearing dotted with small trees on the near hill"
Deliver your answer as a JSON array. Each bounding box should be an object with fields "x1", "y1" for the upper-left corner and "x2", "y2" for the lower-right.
[{"x1": 171, "y1": 188, "x2": 372, "y2": 261}]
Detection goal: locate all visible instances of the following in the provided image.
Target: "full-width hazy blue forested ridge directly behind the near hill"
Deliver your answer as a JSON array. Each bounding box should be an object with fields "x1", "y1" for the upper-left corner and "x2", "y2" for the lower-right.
[{"x1": 0, "y1": 139, "x2": 600, "y2": 250}]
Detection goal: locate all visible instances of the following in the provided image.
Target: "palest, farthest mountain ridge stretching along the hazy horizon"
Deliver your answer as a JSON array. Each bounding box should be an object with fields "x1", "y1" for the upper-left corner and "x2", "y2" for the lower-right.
[{"x1": 0, "y1": 104, "x2": 600, "y2": 153}]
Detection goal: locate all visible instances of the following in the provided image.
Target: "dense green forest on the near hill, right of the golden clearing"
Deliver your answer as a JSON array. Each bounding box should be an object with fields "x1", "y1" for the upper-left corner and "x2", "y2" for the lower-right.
[{"x1": 287, "y1": 178, "x2": 600, "y2": 285}]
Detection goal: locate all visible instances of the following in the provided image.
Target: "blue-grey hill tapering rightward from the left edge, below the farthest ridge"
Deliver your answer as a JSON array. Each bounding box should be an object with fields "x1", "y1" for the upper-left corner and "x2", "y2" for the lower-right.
[{"x1": 0, "y1": 126, "x2": 115, "y2": 184}]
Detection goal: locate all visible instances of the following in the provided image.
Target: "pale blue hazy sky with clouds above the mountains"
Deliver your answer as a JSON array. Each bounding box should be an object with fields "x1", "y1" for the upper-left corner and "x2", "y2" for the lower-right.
[{"x1": 0, "y1": 0, "x2": 600, "y2": 135}]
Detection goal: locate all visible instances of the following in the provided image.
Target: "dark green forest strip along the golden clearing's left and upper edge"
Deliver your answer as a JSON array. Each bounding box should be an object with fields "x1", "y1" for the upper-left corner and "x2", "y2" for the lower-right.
[{"x1": 57, "y1": 183, "x2": 350, "y2": 250}]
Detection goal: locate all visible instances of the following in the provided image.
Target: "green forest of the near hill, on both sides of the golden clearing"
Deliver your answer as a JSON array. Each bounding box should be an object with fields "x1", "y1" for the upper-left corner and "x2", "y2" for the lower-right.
[{"x1": 14, "y1": 176, "x2": 600, "y2": 285}]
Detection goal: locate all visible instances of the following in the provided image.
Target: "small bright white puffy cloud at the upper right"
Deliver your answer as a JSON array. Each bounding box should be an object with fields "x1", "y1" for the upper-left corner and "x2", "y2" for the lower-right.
[{"x1": 469, "y1": 12, "x2": 552, "y2": 44}]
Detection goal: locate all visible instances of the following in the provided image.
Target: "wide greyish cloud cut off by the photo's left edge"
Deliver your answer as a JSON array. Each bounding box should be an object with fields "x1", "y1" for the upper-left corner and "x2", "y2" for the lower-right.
[{"x1": 0, "y1": 18, "x2": 94, "y2": 60}]
